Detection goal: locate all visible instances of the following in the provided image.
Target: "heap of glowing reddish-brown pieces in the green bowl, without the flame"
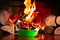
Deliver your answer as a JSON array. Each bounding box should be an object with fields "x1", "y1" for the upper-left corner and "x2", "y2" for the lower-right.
[{"x1": 18, "y1": 19, "x2": 39, "y2": 30}]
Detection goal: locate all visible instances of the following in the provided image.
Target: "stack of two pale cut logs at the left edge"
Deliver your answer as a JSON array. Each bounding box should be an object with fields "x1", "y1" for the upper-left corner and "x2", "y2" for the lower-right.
[{"x1": 0, "y1": 10, "x2": 14, "y2": 34}]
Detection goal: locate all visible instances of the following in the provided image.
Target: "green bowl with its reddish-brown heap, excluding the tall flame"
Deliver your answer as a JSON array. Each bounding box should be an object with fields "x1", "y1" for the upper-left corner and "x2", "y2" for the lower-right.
[{"x1": 17, "y1": 20, "x2": 40, "y2": 37}]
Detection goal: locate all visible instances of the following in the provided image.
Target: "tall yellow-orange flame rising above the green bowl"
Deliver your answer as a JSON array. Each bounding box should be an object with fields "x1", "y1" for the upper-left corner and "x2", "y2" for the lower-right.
[{"x1": 24, "y1": 0, "x2": 36, "y2": 22}]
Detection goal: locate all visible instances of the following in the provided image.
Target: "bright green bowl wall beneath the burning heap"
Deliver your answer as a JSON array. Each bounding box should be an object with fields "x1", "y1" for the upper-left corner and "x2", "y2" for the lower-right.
[{"x1": 17, "y1": 30, "x2": 38, "y2": 37}]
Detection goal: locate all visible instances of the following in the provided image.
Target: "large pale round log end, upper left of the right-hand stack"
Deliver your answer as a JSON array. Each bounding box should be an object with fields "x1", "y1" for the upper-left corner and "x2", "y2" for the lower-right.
[{"x1": 45, "y1": 15, "x2": 56, "y2": 27}]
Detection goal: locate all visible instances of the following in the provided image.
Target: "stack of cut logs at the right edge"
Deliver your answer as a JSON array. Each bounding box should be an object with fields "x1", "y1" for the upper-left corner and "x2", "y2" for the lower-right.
[{"x1": 44, "y1": 15, "x2": 60, "y2": 35}]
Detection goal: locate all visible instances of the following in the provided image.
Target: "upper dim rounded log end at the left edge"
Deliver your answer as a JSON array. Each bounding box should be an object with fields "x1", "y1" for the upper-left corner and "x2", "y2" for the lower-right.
[{"x1": 0, "y1": 10, "x2": 9, "y2": 25}]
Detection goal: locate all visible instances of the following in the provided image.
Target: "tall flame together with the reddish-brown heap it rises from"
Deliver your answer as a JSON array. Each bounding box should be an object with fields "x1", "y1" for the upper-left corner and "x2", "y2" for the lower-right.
[{"x1": 17, "y1": 0, "x2": 39, "y2": 30}]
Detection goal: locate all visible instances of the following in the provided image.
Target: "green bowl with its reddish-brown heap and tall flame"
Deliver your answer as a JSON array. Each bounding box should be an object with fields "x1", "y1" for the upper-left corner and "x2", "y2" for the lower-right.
[{"x1": 17, "y1": 0, "x2": 39, "y2": 37}]
